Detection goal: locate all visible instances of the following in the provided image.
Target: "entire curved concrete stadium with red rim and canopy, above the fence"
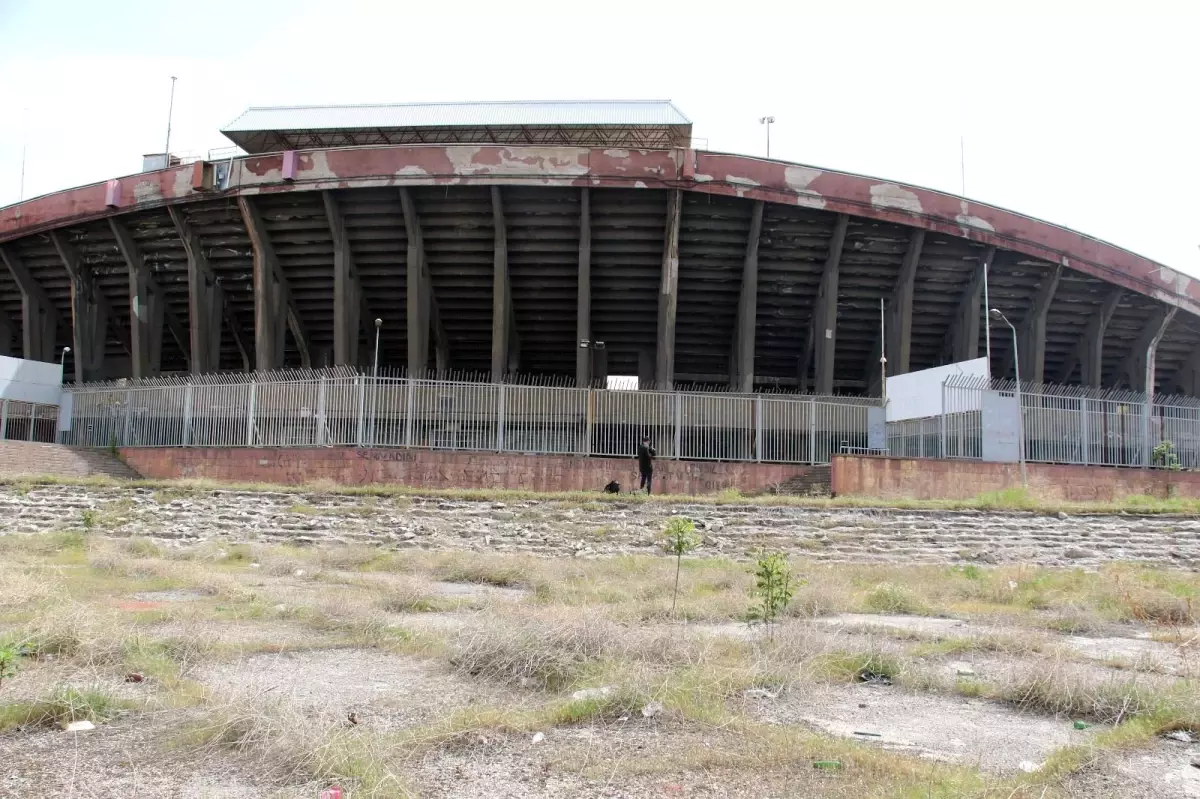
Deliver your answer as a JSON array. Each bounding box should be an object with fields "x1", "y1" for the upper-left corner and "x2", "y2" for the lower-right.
[{"x1": 0, "y1": 102, "x2": 1200, "y2": 395}]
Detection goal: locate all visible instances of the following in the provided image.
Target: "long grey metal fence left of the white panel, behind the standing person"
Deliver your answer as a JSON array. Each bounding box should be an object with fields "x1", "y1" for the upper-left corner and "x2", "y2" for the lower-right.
[{"x1": 59, "y1": 370, "x2": 878, "y2": 463}]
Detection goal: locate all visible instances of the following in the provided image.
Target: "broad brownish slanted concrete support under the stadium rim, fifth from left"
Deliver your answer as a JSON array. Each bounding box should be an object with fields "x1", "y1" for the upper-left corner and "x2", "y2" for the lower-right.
[{"x1": 238, "y1": 197, "x2": 312, "y2": 372}]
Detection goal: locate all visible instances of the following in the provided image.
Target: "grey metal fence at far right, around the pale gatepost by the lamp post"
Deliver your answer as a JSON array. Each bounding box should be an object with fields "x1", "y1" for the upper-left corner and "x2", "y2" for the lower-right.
[{"x1": 888, "y1": 377, "x2": 1200, "y2": 469}]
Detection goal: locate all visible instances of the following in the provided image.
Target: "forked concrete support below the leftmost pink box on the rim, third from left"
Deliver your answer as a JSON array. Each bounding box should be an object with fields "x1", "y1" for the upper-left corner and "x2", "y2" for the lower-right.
[{"x1": 108, "y1": 217, "x2": 191, "y2": 379}]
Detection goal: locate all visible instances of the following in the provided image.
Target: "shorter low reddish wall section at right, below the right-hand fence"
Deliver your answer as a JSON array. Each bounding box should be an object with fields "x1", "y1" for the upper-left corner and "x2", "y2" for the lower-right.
[{"x1": 833, "y1": 455, "x2": 1200, "y2": 501}]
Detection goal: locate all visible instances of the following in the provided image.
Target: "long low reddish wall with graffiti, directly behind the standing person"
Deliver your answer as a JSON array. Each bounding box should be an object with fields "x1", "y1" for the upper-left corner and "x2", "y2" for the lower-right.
[{"x1": 121, "y1": 447, "x2": 809, "y2": 494}]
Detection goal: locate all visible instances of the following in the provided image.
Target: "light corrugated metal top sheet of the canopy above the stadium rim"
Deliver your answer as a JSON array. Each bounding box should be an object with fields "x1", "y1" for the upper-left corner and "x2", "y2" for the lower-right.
[{"x1": 221, "y1": 100, "x2": 691, "y2": 133}]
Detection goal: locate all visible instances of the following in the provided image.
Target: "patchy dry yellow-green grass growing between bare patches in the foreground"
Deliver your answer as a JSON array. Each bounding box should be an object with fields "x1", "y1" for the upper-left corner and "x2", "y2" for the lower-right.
[{"x1": 0, "y1": 523, "x2": 1200, "y2": 797}]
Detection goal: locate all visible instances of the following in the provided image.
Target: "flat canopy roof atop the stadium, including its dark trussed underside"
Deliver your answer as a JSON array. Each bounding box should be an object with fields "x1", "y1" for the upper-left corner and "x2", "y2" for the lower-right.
[{"x1": 221, "y1": 100, "x2": 691, "y2": 152}]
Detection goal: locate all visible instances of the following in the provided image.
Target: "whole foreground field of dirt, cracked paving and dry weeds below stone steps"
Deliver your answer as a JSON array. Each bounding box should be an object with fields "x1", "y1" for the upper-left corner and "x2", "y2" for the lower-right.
[{"x1": 0, "y1": 484, "x2": 1200, "y2": 799}]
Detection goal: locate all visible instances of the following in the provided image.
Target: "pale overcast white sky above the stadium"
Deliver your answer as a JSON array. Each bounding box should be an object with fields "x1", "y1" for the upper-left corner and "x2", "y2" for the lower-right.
[{"x1": 0, "y1": 0, "x2": 1200, "y2": 276}]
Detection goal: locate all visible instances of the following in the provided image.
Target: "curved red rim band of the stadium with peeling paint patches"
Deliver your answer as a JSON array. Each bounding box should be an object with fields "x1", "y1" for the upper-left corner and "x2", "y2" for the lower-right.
[{"x1": 0, "y1": 145, "x2": 1200, "y2": 316}]
